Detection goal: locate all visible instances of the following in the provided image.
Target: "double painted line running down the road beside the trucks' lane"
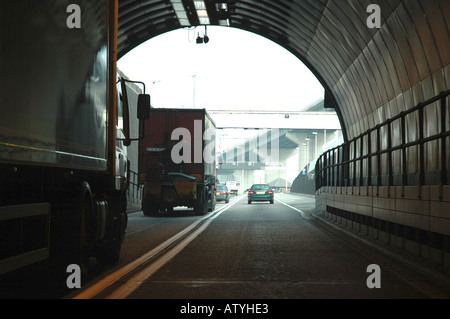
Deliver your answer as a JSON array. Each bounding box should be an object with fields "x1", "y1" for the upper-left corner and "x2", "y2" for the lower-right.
[{"x1": 73, "y1": 198, "x2": 242, "y2": 299}]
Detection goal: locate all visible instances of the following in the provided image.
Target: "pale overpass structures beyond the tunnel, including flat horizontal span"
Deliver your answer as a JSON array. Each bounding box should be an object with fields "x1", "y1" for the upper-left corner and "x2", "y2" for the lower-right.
[{"x1": 208, "y1": 110, "x2": 341, "y2": 192}]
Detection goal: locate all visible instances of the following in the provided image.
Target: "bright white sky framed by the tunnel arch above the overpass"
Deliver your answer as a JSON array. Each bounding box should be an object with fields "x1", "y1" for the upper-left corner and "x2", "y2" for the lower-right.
[{"x1": 118, "y1": 26, "x2": 324, "y2": 111}]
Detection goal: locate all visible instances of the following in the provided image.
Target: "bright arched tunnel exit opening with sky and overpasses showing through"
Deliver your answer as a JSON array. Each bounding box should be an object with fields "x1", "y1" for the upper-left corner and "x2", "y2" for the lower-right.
[{"x1": 118, "y1": 26, "x2": 344, "y2": 198}]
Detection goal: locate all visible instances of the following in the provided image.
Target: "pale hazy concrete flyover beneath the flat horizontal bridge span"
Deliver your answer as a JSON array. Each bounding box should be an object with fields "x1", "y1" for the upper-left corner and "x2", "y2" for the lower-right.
[{"x1": 217, "y1": 128, "x2": 343, "y2": 194}]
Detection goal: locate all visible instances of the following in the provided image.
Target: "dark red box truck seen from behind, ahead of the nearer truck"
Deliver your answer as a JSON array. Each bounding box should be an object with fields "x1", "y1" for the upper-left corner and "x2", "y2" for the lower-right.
[{"x1": 138, "y1": 108, "x2": 216, "y2": 216}]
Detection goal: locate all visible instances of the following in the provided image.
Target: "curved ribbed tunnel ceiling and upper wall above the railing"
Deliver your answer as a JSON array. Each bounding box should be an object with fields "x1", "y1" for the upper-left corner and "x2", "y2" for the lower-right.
[{"x1": 118, "y1": 0, "x2": 450, "y2": 139}]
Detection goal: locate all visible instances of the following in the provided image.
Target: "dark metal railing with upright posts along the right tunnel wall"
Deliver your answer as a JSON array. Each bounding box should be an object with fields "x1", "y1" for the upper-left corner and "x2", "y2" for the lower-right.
[{"x1": 315, "y1": 90, "x2": 450, "y2": 195}]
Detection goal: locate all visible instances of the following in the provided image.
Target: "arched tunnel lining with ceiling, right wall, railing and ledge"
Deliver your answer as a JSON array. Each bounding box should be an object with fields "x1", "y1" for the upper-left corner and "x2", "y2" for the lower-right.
[{"x1": 118, "y1": 0, "x2": 450, "y2": 264}]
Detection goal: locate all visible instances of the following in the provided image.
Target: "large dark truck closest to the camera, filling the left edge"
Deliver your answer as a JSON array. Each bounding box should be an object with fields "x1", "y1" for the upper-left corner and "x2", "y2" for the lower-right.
[{"x1": 0, "y1": 0, "x2": 150, "y2": 274}]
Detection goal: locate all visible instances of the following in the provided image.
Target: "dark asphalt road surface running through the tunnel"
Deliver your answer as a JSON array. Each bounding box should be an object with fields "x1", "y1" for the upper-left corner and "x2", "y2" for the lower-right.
[{"x1": 2, "y1": 194, "x2": 450, "y2": 302}]
